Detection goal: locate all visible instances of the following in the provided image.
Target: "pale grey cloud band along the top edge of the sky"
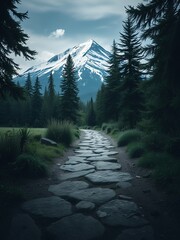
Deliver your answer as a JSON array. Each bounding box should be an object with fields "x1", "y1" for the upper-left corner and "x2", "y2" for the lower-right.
[{"x1": 22, "y1": 0, "x2": 143, "y2": 20}]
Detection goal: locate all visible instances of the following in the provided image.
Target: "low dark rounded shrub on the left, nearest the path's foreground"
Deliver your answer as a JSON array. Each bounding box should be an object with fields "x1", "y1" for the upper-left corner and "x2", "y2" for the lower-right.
[{"x1": 14, "y1": 153, "x2": 47, "y2": 178}]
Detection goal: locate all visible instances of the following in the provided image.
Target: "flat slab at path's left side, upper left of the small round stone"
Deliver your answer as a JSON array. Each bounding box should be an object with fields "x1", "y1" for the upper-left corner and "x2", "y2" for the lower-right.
[{"x1": 48, "y1": 181, "x2": 89, "y2": 196}]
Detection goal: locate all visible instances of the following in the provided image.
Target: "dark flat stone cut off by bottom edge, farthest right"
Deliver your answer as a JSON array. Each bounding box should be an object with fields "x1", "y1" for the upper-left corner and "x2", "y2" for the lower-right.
[{"x1": 116, "y1": 226, "x2": 155, "y2": 240}]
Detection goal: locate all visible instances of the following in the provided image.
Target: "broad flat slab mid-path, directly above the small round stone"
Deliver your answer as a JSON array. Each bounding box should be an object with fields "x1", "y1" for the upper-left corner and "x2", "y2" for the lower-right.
[{"x1": 69, "y1": 187, "x2": 116, "y2": 204}]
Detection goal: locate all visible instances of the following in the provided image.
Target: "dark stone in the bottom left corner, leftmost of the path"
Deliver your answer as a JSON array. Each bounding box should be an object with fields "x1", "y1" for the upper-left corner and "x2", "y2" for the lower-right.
[{"x1": 8, "y1": 214, "x2": 41, "y2": 240}]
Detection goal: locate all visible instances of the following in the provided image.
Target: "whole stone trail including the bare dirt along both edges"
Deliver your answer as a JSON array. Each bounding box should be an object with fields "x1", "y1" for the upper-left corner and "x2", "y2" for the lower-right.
[{"x1": 8, "y1": 130, "x2": 180, "y2": 240}]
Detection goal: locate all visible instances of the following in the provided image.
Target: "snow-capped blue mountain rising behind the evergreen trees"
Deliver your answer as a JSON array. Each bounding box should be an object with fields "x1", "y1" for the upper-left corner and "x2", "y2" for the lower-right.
[{"x1": 16, "y1": 40, "x2": 110, "y2": 101}]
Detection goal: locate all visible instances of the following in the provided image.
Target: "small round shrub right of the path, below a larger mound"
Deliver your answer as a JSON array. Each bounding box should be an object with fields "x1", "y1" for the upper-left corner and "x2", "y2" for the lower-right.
[{"x1": 127, "y1": 142, "x2": 145, "y2": 158}]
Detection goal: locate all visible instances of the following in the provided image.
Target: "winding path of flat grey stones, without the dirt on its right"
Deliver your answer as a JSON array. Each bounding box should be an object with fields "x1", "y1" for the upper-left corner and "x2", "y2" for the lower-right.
[{"x1": 10, "y1": 130, "x2": 154, "y2": 240}]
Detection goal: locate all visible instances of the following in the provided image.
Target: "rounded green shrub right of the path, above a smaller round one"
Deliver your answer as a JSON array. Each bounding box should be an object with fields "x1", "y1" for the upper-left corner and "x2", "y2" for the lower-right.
[{"x1": 118, "y1": 129, "x2": 142, "y2": 147}]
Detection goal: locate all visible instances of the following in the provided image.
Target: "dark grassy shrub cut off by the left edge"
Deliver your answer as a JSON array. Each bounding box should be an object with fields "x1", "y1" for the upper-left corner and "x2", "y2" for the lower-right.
[{"x1": 0, "y1": 130, "x2": 21, "y2": 162}]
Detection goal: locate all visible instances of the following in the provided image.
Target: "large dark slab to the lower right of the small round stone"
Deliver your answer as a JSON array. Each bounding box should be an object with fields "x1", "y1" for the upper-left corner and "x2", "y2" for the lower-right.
[{"x1": 99, "y1": 199, "x2": 148, "y2": 228}]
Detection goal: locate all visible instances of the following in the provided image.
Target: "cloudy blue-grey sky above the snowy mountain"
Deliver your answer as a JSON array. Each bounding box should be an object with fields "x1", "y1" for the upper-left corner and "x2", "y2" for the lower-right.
[{"x1": 15, "y1": 0, "x2": 143, "y2": 72}]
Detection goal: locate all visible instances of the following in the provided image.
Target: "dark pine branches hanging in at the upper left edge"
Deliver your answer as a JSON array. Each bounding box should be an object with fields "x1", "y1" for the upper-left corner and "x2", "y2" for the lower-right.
[{"x1": 0, "y1": 0, "x2": 36, "y2": 98}]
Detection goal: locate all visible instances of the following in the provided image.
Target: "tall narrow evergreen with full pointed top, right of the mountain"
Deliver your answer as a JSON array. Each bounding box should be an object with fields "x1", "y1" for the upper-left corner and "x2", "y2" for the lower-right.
[{"x1": 119, "y1": 17, "x2": 142, "y2": 128}]
